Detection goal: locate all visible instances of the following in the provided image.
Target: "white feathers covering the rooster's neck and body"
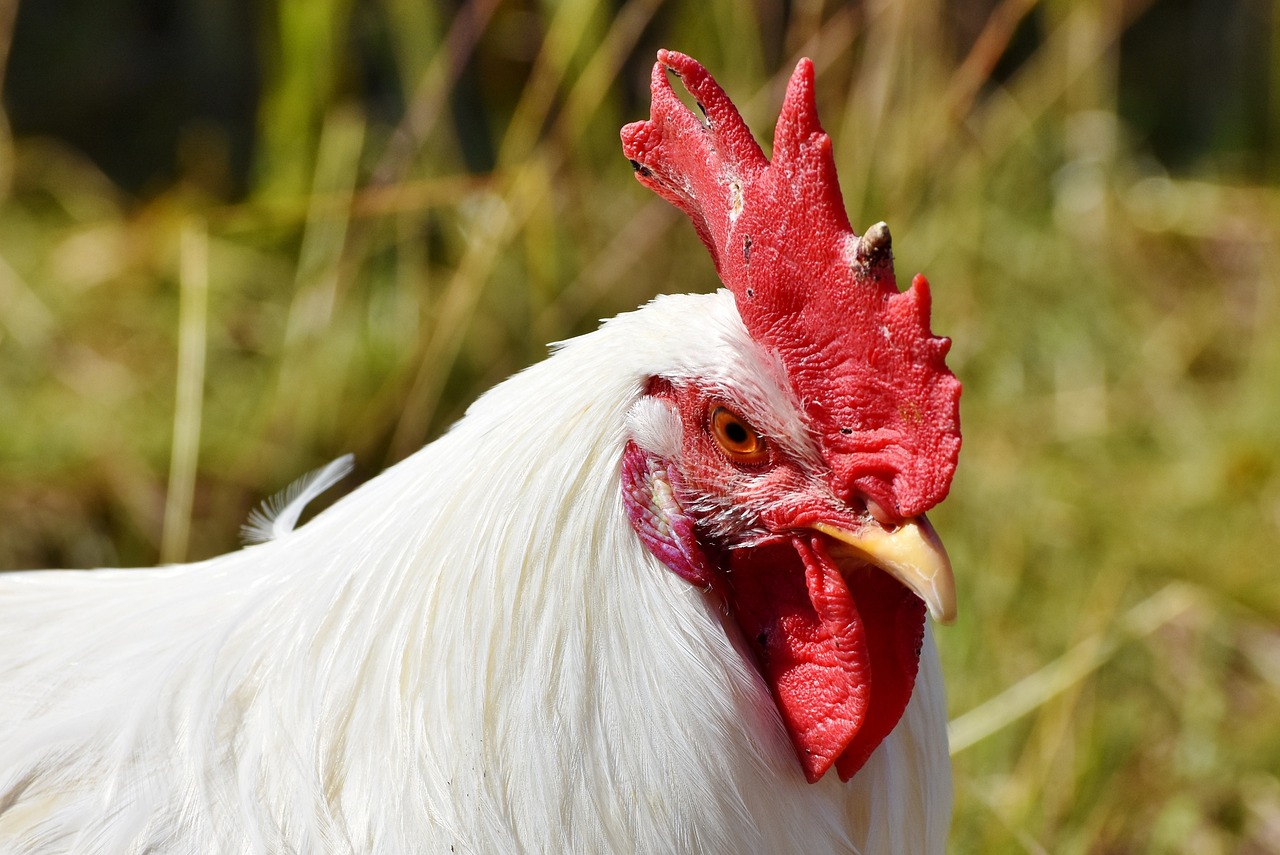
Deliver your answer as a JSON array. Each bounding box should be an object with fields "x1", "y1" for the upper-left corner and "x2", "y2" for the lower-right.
[{"x1": 0, "y1": 292, "x2": 951, "y2": 855}]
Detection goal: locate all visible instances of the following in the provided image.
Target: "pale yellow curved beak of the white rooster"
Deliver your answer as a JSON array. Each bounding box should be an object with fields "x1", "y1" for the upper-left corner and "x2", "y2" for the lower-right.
[{"x1": 812, "y1": 515, "x2": 956, "y2": 623}]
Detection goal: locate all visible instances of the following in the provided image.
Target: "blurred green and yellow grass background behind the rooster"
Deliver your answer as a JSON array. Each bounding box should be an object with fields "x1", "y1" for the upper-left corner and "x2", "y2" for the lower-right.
[{"x1": 0, "y1": 0, "x2": 1280, "y2": 854}]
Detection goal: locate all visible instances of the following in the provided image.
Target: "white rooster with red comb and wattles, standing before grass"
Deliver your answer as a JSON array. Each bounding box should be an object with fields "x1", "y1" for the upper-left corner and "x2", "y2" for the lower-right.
[{"x1": 0, "y1": 51, "x2": 960, "y2": 855}]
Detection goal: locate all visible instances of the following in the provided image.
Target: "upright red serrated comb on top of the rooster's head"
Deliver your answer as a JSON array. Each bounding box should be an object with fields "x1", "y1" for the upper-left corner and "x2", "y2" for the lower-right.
[{"x1": 622, "y1": 50, "x2": 960, "y2": 517}]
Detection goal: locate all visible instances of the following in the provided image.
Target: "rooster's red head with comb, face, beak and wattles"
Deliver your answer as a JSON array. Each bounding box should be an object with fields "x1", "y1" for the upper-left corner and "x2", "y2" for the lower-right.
[{"x1": 622, "y1": 51, "x2": 960, "y2": 782}]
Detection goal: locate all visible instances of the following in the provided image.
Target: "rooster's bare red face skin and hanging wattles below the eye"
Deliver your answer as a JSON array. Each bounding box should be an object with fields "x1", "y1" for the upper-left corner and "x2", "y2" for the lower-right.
[{"x1": 622, "y1": 381, "x2": 924, "y2": 782}]
